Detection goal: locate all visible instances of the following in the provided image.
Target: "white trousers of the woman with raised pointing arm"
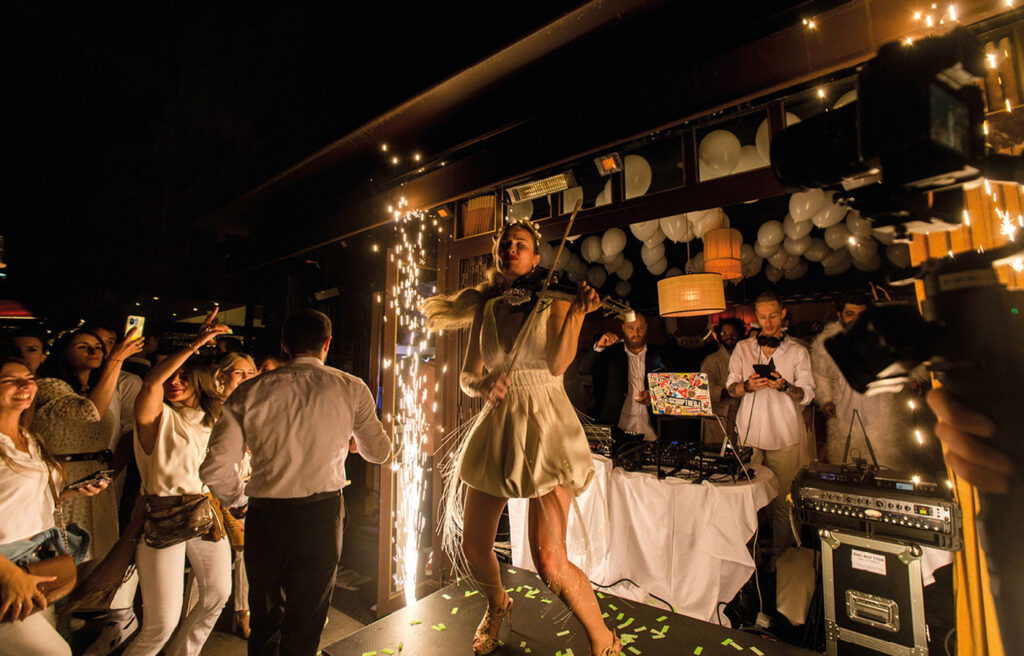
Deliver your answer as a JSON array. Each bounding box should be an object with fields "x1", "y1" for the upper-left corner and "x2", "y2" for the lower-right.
[{"x1": 124, "y1": 537, "x2": 231, "y2": 656}]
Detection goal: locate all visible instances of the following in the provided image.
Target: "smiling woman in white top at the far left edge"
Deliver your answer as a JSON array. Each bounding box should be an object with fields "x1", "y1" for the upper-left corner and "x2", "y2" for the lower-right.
[{"x1": 0, "y1": 357, "x2": 105, "y2": 656}]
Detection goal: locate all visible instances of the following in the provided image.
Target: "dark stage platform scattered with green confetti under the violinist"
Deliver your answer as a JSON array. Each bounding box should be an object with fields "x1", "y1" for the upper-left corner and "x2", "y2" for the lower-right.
[{"x1": 324, "y1": 565, "x2": 815, "y2": 656}]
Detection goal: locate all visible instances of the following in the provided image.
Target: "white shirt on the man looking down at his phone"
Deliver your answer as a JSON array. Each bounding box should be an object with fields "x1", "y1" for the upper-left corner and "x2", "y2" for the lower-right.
[{"x1": 726, "y1": 337, "x2": 814, "y2": 450}]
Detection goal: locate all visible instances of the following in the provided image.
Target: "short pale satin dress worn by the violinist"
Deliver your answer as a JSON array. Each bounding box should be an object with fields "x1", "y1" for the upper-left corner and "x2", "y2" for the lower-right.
[{"x1": 458, "y1": 299, "x2": 594, "y2": 498}]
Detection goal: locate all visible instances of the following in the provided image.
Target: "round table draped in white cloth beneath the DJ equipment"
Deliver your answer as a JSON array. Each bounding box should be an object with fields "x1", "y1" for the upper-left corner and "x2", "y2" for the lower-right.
[{"x1": 509, "y1": 455, "x2": 778, "y2": 622}]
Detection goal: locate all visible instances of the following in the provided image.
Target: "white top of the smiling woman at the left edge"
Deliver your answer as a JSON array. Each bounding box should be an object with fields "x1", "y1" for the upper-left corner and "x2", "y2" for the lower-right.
[{"x1": 0, "y1": 433, "x2": 58, "y2": 544}]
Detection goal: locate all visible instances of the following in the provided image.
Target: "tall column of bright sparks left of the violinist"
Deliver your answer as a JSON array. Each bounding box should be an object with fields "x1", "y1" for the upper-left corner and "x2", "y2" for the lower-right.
[{"x1": 382, "y1": 199, "x2": 429, "y2": 604}]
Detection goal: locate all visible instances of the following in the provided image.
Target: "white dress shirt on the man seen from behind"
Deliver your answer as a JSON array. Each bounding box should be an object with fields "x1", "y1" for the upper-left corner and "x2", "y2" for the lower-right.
[{"x1": 200, "y1": 357, "x2": 391, "y2": 507}]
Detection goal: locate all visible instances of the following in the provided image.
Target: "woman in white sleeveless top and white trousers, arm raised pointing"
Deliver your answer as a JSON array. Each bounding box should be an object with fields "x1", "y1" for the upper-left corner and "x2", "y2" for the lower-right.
[{"x1": 125, "y1": 311, "x2": 231, "y2": 656}]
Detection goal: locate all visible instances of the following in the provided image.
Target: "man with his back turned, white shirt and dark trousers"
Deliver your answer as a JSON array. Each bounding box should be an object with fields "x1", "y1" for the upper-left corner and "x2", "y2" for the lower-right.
[{"x1": 200, "y1": 310, "x2": 391, "y2": 656}]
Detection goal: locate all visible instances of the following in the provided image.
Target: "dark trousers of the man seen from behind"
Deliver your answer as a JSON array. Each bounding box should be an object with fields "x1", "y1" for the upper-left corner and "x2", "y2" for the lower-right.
[{"x1": 245, "y1": 492, "x2": 341, "y2": 656}]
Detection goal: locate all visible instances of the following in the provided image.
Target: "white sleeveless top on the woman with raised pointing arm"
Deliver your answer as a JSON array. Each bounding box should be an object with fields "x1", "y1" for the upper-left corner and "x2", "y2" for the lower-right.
[{"x1": 135, "y1": 403, "x2": 212, "y2": 496}]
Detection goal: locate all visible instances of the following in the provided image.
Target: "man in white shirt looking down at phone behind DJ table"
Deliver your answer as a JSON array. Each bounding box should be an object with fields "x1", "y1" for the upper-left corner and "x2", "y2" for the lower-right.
[{"x1": 727, "y1": 293, "x2": 814, "y2": 558}]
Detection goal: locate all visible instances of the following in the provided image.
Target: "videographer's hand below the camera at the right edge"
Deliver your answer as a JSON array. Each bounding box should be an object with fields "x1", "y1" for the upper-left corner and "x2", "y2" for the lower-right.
[{"x1": 928, "y1": 388, "x2": 1015, "y2": 494}]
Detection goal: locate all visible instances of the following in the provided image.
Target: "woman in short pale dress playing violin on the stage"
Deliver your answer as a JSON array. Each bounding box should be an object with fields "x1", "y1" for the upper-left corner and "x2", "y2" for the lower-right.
[{"x1": 423, "y1": 221, "x2": 621, "y2": 656}]
